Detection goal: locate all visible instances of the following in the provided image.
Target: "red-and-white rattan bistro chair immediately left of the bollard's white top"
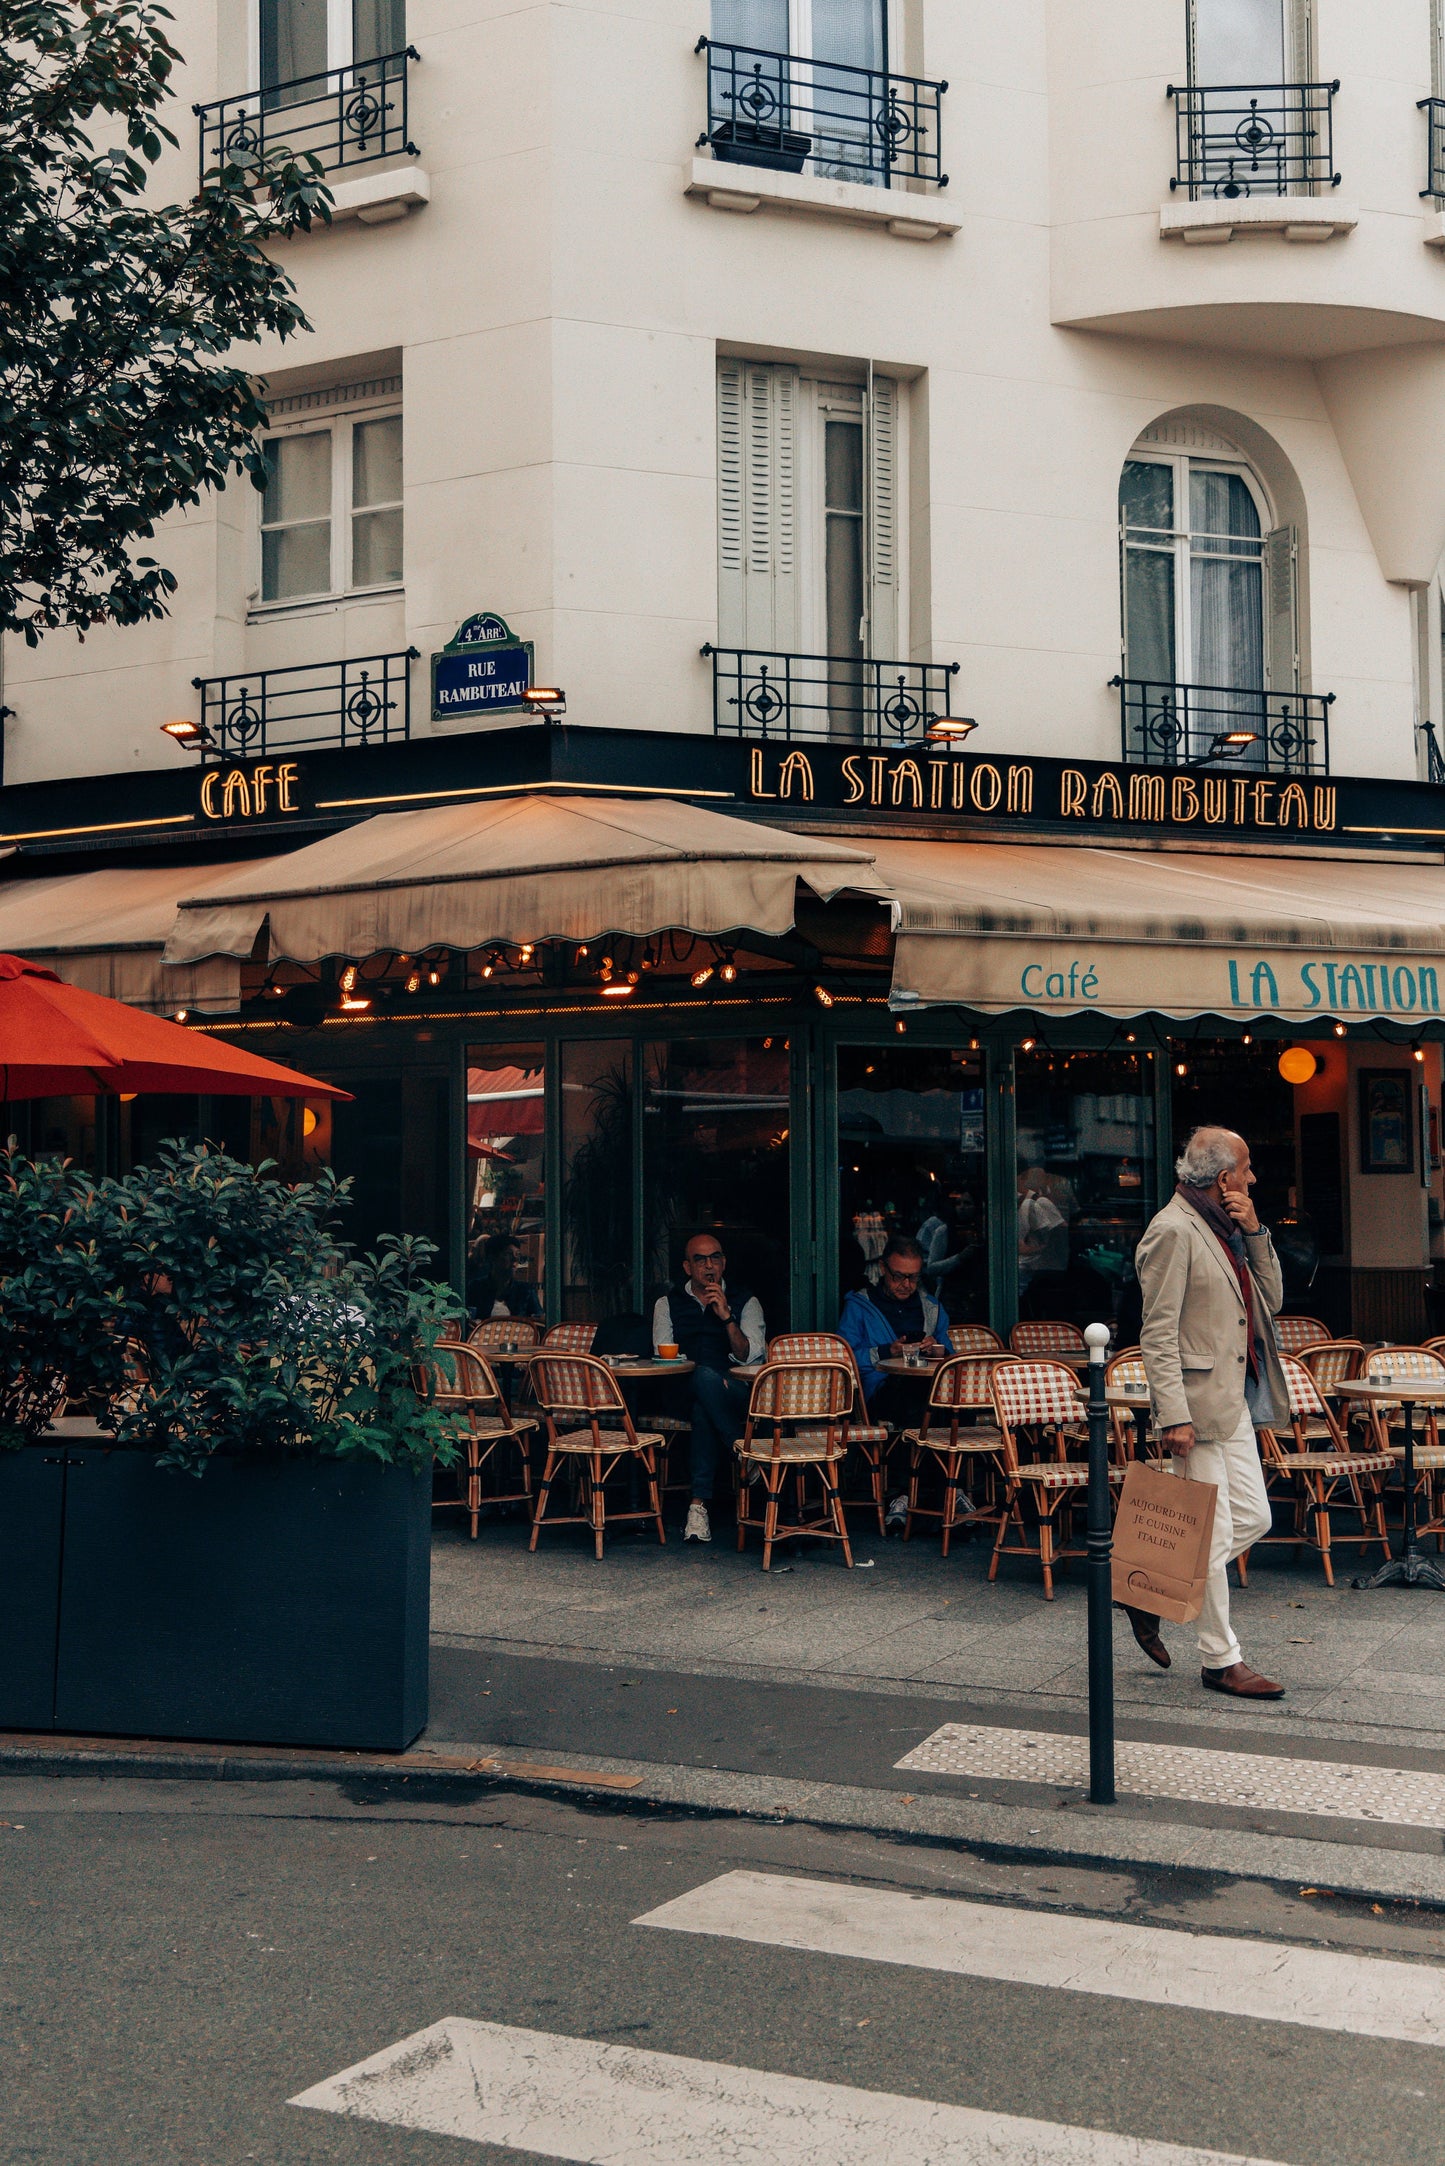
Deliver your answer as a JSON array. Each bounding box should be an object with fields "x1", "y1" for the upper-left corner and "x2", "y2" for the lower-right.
[{"x1": 988, "y1": 1360, "x2": 1124, "y2": 1601}]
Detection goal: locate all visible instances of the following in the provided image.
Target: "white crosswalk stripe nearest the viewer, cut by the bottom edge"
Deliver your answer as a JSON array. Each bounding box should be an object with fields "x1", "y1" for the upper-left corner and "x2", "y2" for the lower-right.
[{"x1": 290, "y1": 2017, "x2": 1270, "y2": 2166}]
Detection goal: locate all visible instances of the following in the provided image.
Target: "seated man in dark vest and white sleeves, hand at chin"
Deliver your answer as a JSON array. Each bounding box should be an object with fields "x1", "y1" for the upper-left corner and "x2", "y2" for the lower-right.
[{"x1": 652, "y1": 1232, "x2": 767, "y2": 1542}]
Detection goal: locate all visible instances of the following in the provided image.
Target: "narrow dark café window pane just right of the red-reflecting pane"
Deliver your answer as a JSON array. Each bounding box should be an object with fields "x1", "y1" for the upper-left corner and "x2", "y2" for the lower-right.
[{"x1": 561, "y1": 1038, "x2": 637, "y2": 1323}]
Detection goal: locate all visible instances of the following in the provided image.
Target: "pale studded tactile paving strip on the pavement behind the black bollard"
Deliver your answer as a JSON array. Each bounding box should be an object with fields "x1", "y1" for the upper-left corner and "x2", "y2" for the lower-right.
[{"x1": 895, "y1": 1722, "x2": 1445, "y2": 1828}]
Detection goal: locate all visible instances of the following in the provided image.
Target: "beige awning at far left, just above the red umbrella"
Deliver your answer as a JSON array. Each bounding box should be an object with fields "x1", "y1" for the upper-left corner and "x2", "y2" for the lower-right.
[{"x1": 0, "y1": 864, "x2": 258, "y2": 1014}]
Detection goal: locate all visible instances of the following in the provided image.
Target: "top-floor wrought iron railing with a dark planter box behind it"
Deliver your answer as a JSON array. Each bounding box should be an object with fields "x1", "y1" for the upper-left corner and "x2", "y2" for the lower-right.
[{"x1": 695, "y1": 37, "x2": 949, "y2": 188}]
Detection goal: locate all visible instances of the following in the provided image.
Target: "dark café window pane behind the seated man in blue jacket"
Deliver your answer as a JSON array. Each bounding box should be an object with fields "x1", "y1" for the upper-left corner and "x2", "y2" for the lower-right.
[{"x1": 838, "y1": 1046, "x2": 988, "y2": 1323}]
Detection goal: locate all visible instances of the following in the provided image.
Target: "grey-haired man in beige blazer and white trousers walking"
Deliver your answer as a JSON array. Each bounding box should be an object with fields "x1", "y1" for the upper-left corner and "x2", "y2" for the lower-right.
[{"x1": 1129, "y1": 1128, "x2": 1289, "y2": 1700}]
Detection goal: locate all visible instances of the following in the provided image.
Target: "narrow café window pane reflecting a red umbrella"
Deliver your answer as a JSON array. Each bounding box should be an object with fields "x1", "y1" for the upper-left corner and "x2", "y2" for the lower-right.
[{"x1": 466, "y1": 1044, "x2": 546, "y2": 1317}]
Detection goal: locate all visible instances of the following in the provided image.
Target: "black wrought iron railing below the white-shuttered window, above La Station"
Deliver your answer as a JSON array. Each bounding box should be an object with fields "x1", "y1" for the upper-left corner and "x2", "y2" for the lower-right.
[{"x1": 702, "y1": 645, "x2": 960, "y2": 747}]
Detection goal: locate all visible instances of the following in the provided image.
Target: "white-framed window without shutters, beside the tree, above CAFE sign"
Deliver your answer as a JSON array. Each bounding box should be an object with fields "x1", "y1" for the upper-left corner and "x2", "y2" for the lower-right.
[{"x1": 258, "y1": 414, "x2": 403, "y2": 606}]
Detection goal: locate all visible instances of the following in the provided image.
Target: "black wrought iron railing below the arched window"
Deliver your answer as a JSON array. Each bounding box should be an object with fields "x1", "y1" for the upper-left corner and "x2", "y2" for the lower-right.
[{"x1": 1109, "y1": 678, "x2": 1335, "y2": 775}]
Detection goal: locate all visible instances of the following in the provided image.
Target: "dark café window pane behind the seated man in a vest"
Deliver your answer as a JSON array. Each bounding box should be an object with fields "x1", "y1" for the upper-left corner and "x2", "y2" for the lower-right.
[{"x1": 641, "y1": 1038, "x2": 789, "y2": 1334}]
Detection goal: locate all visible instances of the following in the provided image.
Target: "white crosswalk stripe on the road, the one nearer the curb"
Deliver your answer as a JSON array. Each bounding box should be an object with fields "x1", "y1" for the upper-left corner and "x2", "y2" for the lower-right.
[{"x1": 635, "y1": 1871, "x2": 1445, "y2": 2047}]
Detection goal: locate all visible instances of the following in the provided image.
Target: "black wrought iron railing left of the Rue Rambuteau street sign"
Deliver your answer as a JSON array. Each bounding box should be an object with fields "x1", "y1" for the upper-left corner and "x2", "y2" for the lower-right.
[{"x1": 191, "y1": 648, "x2": 418, "y2": 760}]
